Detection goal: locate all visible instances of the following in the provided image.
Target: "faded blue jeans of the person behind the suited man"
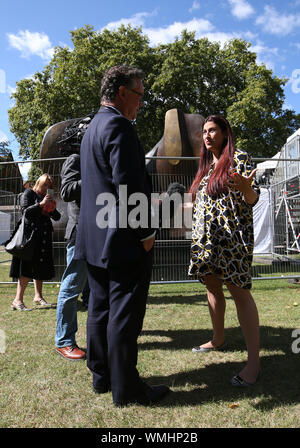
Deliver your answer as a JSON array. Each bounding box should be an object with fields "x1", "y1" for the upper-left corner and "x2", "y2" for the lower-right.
[{"x1": 55, "y1": 240, "x2": 87, "y2": 347}]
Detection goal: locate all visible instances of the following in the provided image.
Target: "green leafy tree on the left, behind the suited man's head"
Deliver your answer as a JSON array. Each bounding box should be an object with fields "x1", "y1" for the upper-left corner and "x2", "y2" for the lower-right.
[{"x1": 9, "y1": 26, "x2": 153, "y2": 158}]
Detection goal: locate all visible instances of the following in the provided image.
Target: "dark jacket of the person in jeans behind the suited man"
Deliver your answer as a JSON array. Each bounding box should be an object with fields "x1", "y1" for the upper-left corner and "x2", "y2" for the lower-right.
[{"x1": 60, "y1": 154, "x2": 81, "y2": 240}]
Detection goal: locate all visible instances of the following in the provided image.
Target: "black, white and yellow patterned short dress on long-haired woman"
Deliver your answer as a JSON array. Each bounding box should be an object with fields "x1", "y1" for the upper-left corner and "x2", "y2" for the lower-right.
[{"x1": 189, "y1": 150, "x2": 260, "y2": 289}]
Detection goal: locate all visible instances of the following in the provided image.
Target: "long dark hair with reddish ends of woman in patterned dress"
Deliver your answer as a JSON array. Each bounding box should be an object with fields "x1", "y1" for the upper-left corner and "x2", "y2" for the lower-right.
[{"x1": 190, "y1": 115, "x2": 235, "y2": 201}]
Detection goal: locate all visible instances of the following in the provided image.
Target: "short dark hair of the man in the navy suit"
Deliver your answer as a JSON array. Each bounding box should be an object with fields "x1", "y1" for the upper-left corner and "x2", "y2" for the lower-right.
[{"x1": 101, "y1": 65, "x2": 145, "y2": 101}]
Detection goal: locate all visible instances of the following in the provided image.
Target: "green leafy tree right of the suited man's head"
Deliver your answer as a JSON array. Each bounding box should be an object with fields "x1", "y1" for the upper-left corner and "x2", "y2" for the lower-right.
[{"x1": 152, "y1": 32, "x2": 300, "y2": 157}]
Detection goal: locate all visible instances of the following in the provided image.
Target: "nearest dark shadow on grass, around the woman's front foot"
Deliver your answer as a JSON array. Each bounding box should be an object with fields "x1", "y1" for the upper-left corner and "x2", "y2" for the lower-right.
[{"x1": 149, "y1": 355, "x2": 300, "y2": 412}]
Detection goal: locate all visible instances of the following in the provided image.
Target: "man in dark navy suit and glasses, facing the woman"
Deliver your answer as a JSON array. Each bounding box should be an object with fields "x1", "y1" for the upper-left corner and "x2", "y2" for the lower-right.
[{"x1": 75, "y1": 66, "x2": 169, "y2": 406}]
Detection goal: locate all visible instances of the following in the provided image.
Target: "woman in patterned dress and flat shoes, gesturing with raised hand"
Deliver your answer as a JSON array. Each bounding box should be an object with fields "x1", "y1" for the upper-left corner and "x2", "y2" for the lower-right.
[{"x1": 189, "y1": 115, "x2": 260, "y2": 387}]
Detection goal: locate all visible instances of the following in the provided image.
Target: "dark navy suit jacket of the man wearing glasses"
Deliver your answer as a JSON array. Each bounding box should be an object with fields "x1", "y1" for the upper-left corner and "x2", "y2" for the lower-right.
[{"x1": 75, "y1": 107, "x2": 153, "y2": 267}]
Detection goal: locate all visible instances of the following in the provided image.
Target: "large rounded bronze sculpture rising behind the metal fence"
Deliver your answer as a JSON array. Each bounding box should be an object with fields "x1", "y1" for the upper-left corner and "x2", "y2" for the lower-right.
[{"x1": 40, "y1": 109, "x2": 204, "y2": 182}]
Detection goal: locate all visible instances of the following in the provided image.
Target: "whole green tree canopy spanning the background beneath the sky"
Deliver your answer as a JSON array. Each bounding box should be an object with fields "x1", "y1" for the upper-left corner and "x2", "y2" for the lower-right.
[{"x1": 9, "y1": 25, "x2": 300, "y2": 158}]
